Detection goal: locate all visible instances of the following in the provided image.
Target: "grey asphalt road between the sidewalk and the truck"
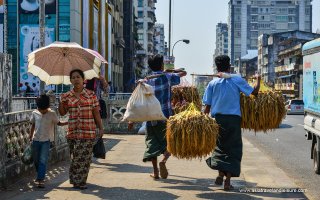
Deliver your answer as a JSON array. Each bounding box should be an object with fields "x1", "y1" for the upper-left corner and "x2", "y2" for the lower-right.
[{"x1": 243, "y1": 115, "x2": 320, "y2": 199}]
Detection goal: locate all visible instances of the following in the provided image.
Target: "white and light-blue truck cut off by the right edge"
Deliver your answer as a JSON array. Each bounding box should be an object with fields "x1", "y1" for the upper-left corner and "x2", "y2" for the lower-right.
[{"x1": 302, "y1": 38, "x2": 320, "y2": 174}]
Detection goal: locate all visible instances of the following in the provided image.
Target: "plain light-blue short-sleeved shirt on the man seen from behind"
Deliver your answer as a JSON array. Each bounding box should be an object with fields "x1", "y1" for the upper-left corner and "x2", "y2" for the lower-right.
[{"x1": 202, "y1": 76, "x2": 253, "y2": 117}]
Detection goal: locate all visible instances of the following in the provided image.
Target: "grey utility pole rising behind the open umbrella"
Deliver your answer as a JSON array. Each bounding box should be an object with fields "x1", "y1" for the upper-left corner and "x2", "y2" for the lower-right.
[{"x1": 39, "y1": 0, "x2": 46, "y2": 94}]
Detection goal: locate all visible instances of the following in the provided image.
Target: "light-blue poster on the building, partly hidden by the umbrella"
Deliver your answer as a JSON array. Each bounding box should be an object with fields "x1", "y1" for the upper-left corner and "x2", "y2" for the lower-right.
[{"x1": 20, "y1": 24, "x2": 55, "y2": 89}]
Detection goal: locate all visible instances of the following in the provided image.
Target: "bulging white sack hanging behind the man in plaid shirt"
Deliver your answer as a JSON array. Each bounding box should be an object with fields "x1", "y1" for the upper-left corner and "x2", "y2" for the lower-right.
[{"x1": 122, "y1": 83, "x2": 166, "y2": 122}]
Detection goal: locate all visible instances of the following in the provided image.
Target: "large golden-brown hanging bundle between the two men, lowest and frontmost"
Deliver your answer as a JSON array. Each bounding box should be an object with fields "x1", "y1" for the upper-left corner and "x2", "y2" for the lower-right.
[{"x1": 166, "y1": 103, "x2": 219, "y2": 159}]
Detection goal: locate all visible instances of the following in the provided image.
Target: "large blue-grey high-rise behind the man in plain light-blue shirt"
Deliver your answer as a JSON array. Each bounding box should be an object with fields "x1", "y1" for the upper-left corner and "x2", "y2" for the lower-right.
[{"x1": 228, "y1": 0, "x2": 312, "y2": 63}]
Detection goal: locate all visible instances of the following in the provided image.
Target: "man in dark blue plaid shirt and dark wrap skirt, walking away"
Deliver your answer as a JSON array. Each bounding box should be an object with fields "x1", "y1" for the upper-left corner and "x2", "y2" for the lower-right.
[{"x1": 134, "y1": 54, "x2": 187, "y2": 179}]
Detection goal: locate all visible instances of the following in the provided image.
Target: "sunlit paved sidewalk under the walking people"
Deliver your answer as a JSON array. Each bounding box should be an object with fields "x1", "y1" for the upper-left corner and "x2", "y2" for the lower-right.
[{"x1": 0, "y1": 135, "x2": 306, "y2": 200}]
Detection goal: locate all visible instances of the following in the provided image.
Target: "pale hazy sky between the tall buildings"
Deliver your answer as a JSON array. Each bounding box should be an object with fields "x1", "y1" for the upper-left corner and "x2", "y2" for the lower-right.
[{"x1": 156, "y1": 0, "x2": 320, "y2": 81}]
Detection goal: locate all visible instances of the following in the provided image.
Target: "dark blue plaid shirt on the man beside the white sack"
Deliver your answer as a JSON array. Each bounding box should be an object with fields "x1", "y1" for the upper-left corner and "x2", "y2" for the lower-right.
[{"x1": 147, "y1": 71, "x2": 180, "y2": 125}]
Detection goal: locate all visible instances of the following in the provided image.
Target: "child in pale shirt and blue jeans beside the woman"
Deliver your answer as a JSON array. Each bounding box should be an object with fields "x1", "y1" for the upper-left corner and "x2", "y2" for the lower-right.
[{"x1": 29, "y1": 94, "x2": 68, "y2": 188}]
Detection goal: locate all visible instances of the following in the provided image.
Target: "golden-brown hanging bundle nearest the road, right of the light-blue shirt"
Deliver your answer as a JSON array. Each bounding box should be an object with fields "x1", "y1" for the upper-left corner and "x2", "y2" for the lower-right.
[{"x1": 240, "y1": 83, "x2": 286, "y2": 132}]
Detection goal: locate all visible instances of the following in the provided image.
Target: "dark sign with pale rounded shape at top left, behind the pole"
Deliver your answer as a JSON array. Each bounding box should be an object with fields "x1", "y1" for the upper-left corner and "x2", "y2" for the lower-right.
[{"x1": 18, "y1": 0, "x2": 56, "y2": 14}]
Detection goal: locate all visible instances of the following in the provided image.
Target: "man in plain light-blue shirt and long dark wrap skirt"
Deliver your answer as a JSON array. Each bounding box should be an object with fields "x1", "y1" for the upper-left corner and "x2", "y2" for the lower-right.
[{"x1": 203, "y1": 55, "x2": 261, "y2": 190}]
